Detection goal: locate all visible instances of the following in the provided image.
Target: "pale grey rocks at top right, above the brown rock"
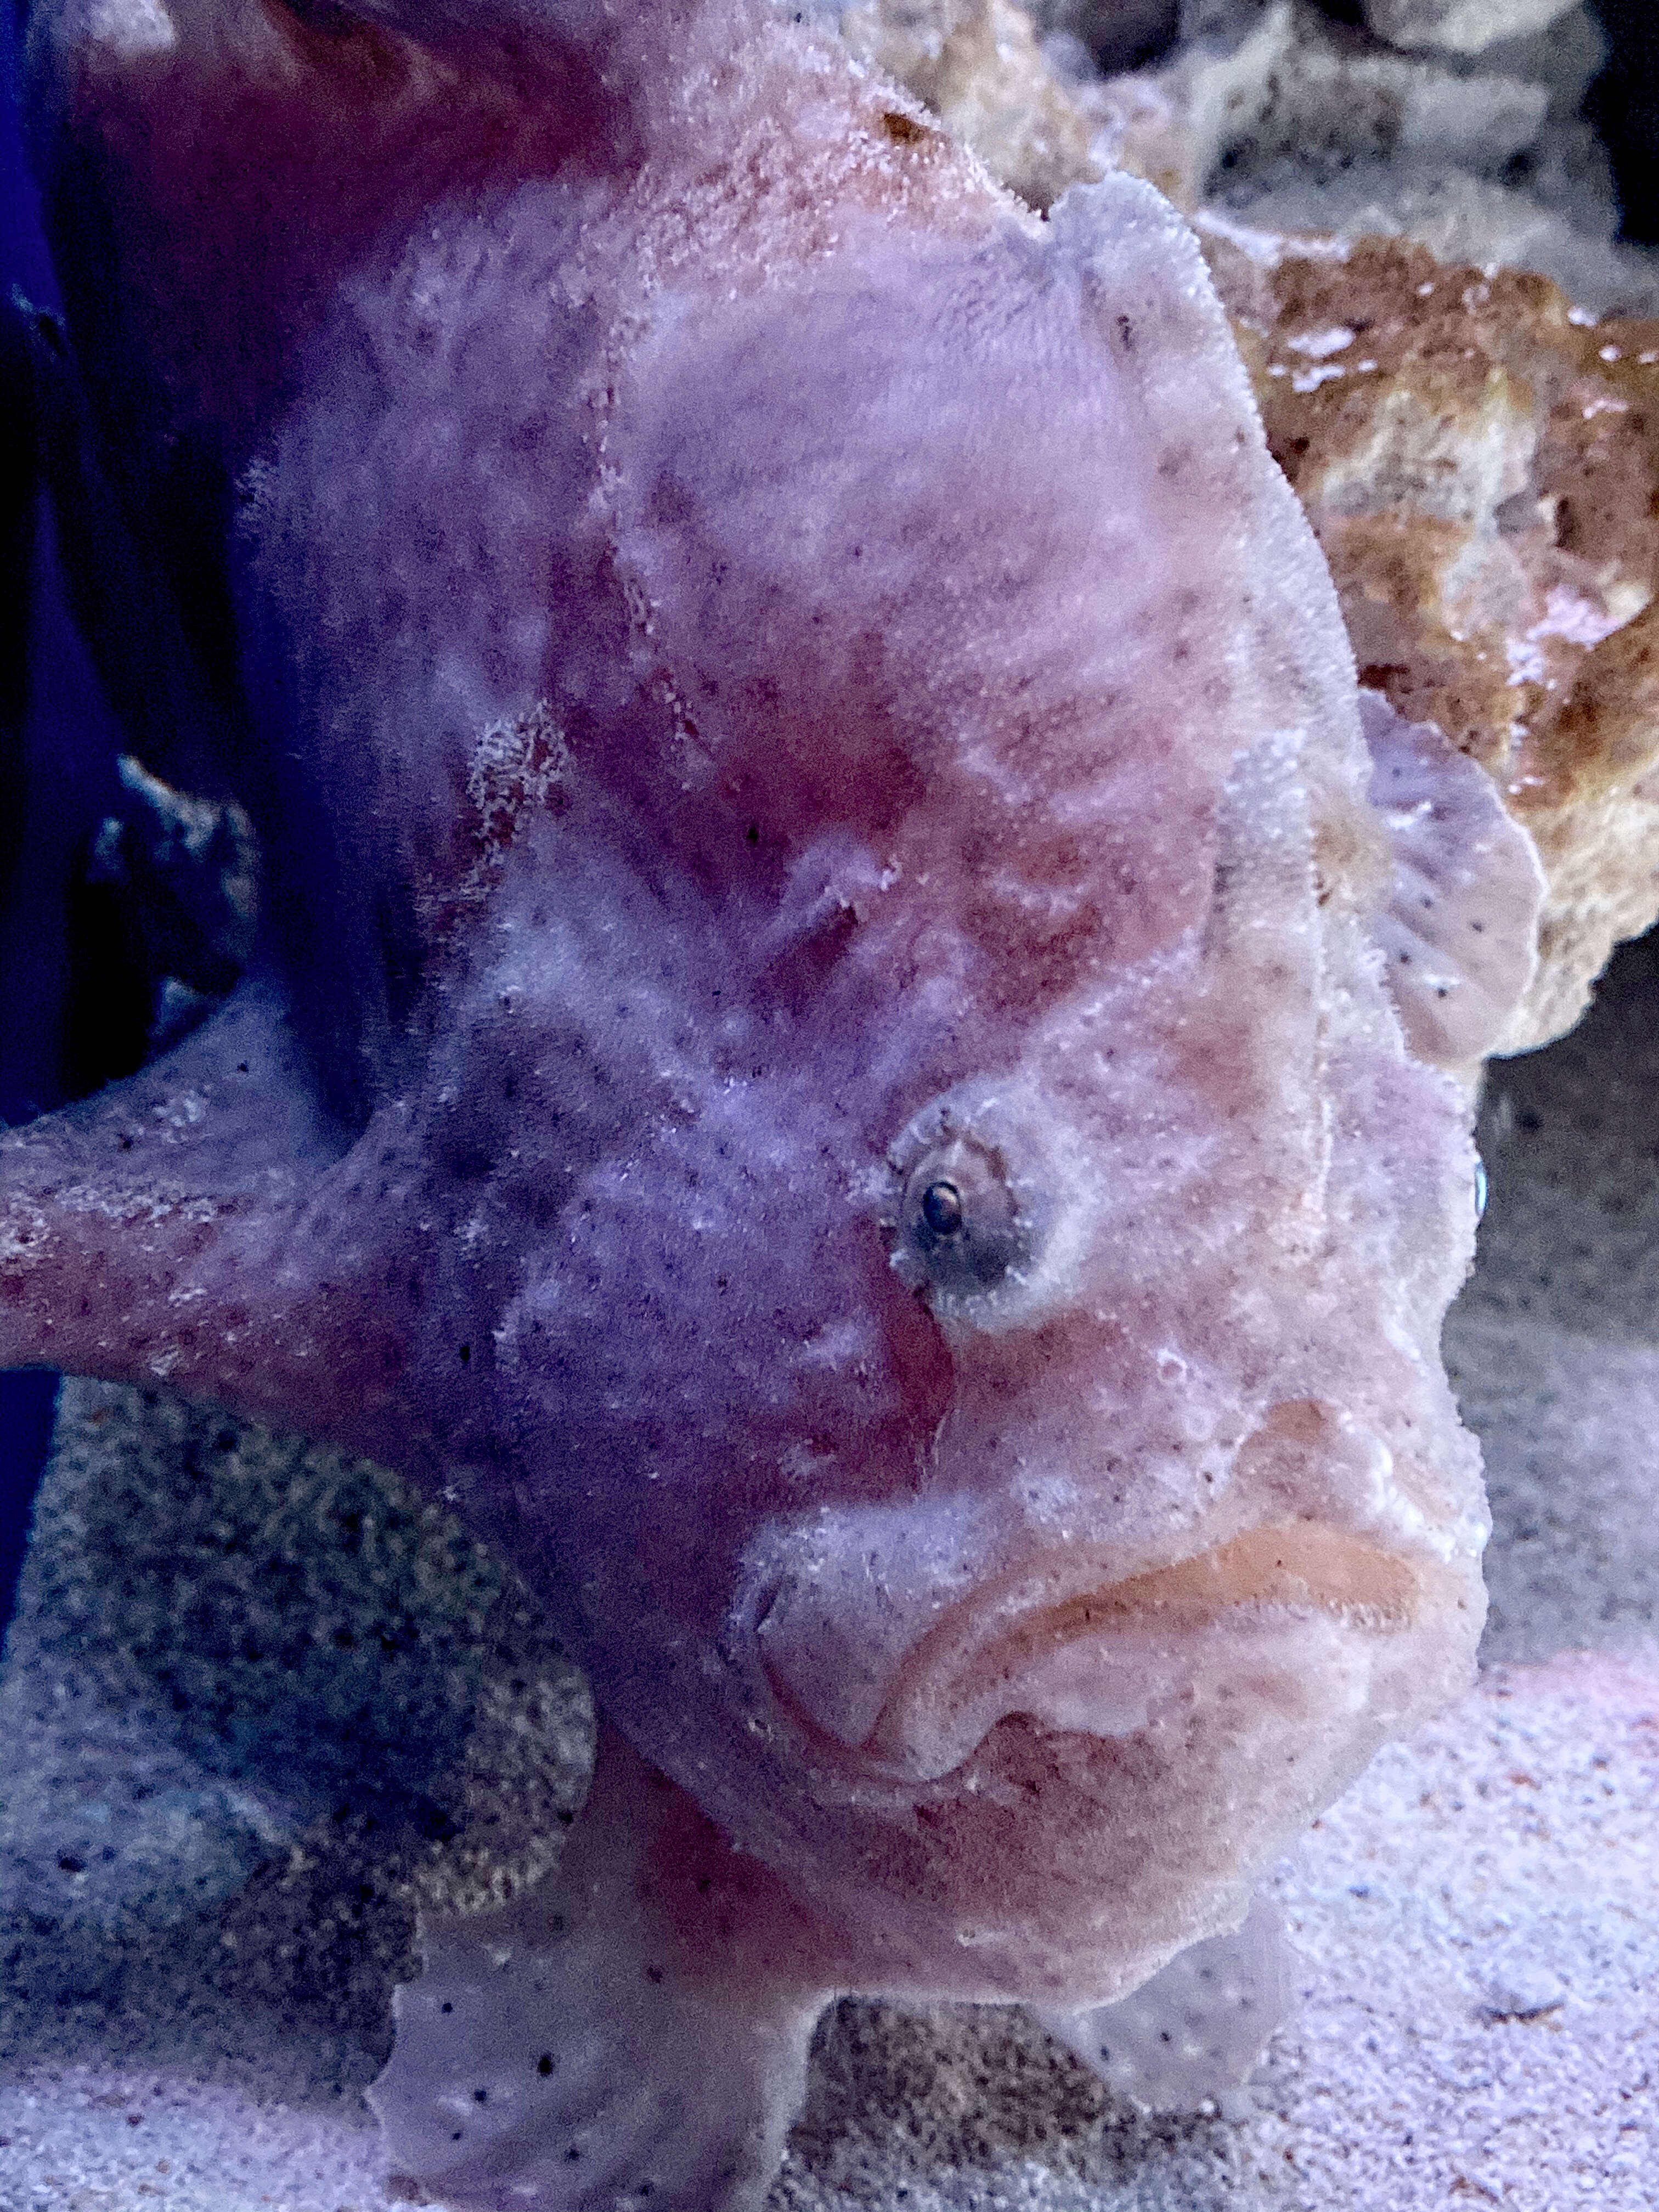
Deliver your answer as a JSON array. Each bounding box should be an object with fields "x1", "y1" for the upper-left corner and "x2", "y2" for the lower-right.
[{"x1": 845, "y1": 0, "x2": 1659, "y2": 312}]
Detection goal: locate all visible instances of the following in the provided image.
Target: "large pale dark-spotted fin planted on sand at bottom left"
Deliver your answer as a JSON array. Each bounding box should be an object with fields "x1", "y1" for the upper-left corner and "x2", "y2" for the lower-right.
[{"x1": 369, "y1": 1730, "x2": 830, "y2": 2212}]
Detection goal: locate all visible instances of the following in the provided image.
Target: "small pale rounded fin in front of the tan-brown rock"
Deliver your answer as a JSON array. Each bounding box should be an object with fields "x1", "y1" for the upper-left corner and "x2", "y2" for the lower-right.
[{"x1": 1361, "y1": 690, "x2": 1544, "y2": 1073}]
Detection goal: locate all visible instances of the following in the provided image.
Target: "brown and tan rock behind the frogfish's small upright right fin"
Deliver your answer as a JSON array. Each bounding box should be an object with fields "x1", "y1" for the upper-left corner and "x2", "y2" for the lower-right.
[{"x1": 1201, "y1": 221, "x2": 1659, "y2": 1051}]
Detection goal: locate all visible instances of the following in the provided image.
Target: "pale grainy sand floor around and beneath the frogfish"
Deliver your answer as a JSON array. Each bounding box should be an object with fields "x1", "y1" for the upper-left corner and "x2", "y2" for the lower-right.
[{"x1": 0, "y1": 943, "x2": 1659, "y2": 2212}]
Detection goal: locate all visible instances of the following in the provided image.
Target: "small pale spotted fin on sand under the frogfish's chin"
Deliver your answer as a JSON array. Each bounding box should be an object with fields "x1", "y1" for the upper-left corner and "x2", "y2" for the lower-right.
[{"x1": 1035, "y1": 1898, "x2": 1290, "y2": 2113}]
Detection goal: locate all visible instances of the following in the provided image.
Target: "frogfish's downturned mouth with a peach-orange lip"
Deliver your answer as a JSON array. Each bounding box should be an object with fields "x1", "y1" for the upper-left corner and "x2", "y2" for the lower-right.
[{"x1": 768, "y1": 1522, "x2": 1447, "y2": 1781}]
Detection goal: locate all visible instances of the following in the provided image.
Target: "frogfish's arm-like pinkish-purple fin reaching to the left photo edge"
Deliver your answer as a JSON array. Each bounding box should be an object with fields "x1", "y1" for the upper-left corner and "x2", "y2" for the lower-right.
[{"x1": 0, "y1": 984, "x2": 387, "y2": 1434}]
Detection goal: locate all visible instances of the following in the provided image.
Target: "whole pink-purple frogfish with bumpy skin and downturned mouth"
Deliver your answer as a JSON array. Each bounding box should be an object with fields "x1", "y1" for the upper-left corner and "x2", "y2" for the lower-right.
[{"x1": 0, "y1": 0, "x2": 1522, "y2": 2203}]
